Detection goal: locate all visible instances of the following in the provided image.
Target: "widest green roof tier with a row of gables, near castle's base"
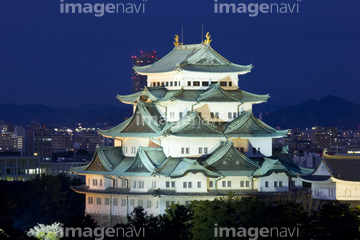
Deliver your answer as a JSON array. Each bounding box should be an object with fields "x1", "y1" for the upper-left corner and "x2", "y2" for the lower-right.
[{"x1": 72, "y1": 141, "x2": 312, "y2": 178}]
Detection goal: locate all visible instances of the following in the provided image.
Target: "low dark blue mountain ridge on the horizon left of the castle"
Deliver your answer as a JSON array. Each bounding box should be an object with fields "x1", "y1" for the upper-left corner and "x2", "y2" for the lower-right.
[{"x1": 0, "y1": 104, "x2": 132, "y2": 128}]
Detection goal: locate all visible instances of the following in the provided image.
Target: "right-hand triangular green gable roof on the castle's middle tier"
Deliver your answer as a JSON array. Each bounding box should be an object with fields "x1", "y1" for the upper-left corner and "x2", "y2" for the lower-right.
[{"x1": 224, "y1": 111, "x2": 288, "y2": 138}]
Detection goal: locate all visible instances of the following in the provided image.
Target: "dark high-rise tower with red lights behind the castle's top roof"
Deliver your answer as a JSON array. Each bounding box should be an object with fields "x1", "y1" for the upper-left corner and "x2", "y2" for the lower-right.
[{"x1": 131, "y1": 51, "x2": 160, "y2": 93}]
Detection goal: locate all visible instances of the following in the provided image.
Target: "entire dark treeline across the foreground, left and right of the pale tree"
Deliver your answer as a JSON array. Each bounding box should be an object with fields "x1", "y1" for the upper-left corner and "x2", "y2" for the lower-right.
[{"x1": 0, "y1": 174, "x2": 360, "y2": 240}]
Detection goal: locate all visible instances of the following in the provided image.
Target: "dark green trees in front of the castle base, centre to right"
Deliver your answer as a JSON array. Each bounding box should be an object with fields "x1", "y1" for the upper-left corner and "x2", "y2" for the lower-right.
[{"x1": 109, "y1": 194, "x2": 360, "y2": 240}]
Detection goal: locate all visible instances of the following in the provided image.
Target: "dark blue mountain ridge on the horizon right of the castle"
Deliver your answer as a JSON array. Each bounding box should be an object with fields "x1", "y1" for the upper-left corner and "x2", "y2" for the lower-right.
[{"x1": 263, "y1": 95, "x2": 360, "y2": 129}]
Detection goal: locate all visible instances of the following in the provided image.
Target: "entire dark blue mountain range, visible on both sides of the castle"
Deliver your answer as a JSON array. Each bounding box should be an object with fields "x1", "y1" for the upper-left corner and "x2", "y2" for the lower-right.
[{"x1": 0, "y1": 96, "x2": 360, "y2": 129}]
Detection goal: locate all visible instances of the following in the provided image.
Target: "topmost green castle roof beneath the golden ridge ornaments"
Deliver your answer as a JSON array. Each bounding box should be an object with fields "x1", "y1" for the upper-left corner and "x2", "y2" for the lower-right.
[{"x1": 134, "y1": 43, "x2": 253, "y2": 75}]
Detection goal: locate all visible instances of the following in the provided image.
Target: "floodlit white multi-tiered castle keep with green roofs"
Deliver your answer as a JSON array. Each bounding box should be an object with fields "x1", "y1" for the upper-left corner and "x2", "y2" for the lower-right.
[{"x1": 73, "y1": 35, "x2": 306, "y2": 222}]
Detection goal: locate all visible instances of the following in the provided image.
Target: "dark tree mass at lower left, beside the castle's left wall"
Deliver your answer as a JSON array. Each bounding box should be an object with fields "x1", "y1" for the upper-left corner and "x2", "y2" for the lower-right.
[{"x1": 0, "y1": 174, "x2": 87, "y2": 239}]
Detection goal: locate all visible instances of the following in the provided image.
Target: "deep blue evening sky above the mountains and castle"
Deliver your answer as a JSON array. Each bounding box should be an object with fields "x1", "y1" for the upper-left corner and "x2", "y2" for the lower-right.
[{"x1": 0, "y1": 0, "x2": 360, "y2": 106}]
